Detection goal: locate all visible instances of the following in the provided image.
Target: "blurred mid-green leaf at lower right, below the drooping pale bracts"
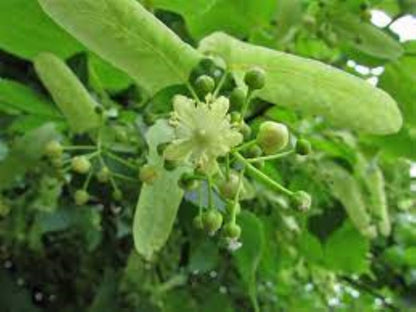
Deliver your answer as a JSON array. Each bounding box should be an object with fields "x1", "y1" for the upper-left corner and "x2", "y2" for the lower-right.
[{"x1": 325, "y1": 222, "x2": 370, "y2": 274}]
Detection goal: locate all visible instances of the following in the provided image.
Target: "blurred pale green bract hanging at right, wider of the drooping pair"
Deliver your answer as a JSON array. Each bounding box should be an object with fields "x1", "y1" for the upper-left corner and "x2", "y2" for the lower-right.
[{"x1": 321, "y1": 162, "x2": 377, "y2": 238}]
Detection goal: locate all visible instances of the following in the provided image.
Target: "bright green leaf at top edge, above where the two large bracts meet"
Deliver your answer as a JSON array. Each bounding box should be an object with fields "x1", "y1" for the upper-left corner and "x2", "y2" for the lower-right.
[{"x1": 152, "y1": 0, "x2": 276, "y2": 39}]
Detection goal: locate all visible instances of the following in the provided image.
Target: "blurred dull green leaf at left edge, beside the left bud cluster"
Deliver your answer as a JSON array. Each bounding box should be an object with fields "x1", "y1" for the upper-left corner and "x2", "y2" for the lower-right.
[{"x1": 0, "y1": 123, "x2": 58, "y2": 190}]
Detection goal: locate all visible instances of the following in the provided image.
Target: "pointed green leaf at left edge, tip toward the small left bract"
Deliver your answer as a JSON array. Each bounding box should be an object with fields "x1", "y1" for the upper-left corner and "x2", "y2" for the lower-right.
[{"x1": 0, "y1": 78, "x2": 60, "y2": 118}]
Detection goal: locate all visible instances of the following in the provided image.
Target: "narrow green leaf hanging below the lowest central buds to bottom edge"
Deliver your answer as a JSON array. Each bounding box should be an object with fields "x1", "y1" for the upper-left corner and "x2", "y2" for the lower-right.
[{"x1": 234, "y1": 211, "x2": 265, "y2": 312}]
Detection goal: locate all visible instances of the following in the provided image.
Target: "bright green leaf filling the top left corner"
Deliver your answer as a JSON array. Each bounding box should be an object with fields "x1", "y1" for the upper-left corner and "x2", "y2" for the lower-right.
[{"x1": 0, "y1": 0, "x2": 83, "y2": 59}]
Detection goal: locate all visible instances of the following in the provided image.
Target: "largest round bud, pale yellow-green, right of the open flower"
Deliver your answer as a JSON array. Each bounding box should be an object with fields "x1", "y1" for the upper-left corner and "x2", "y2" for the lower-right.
[{"x1": 257, "y1": 121, "x2": 289, "y2": 155}]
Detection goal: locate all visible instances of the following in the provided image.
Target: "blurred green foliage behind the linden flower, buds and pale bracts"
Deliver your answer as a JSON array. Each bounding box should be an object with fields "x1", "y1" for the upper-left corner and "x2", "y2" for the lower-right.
[{"x1": 0, "y1": 0, "x2": 416, "y2": 312}]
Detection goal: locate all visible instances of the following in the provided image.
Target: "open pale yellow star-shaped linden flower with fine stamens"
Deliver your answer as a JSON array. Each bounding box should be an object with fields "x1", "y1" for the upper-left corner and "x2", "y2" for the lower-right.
[{"x1": 164, "y1": 95, "x2": 243, "y2": 174}]
